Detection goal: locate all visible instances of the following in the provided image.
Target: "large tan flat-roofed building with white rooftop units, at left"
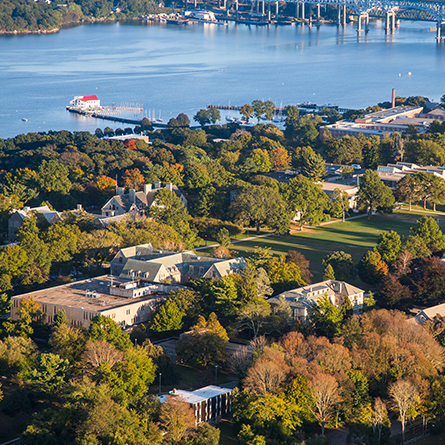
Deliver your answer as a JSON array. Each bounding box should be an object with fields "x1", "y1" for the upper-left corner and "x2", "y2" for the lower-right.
[{"x1": 11, "y1": 275, "x2": 179, "y2": 328}]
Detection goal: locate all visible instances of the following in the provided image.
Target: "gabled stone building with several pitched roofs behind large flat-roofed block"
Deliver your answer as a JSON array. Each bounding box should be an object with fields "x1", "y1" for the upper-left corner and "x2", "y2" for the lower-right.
[{"x1": 110, "y1": 244, "x2": 246, "y2": 283}]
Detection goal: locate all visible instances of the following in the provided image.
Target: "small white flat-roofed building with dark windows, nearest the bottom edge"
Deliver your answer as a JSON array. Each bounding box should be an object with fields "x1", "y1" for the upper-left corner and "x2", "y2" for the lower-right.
[{"x1": 159, "y1": 385, "x2": 233, "y2": 424}]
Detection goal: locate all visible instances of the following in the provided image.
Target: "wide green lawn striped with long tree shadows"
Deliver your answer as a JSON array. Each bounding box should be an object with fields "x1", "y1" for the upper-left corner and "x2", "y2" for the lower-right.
[{"x1": 225, "y1": 210, "x2": 445, "y2": 284}]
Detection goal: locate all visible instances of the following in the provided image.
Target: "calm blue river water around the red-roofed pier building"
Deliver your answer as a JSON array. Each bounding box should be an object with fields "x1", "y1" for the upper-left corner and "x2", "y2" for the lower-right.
[{"x1": 0, "y1": 21, "x2": 445, "y2": 137}]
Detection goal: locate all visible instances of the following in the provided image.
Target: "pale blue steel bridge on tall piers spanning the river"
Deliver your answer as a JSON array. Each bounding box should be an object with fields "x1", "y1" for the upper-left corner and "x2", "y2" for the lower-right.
[{"x1": 212, "y1": 0, "x2": 445, "y2": 41}]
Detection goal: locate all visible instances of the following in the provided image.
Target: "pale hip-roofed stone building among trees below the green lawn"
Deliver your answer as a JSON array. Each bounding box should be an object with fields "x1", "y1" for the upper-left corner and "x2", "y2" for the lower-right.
[{"x1": 267, "y1": 280, "x2": 364, "y2": 321}]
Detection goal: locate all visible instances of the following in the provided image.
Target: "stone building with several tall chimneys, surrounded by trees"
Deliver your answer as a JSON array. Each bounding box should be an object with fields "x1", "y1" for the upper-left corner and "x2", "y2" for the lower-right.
[{"x1": 102, "y1": 181, "x2": 187, "y2": 217}]
